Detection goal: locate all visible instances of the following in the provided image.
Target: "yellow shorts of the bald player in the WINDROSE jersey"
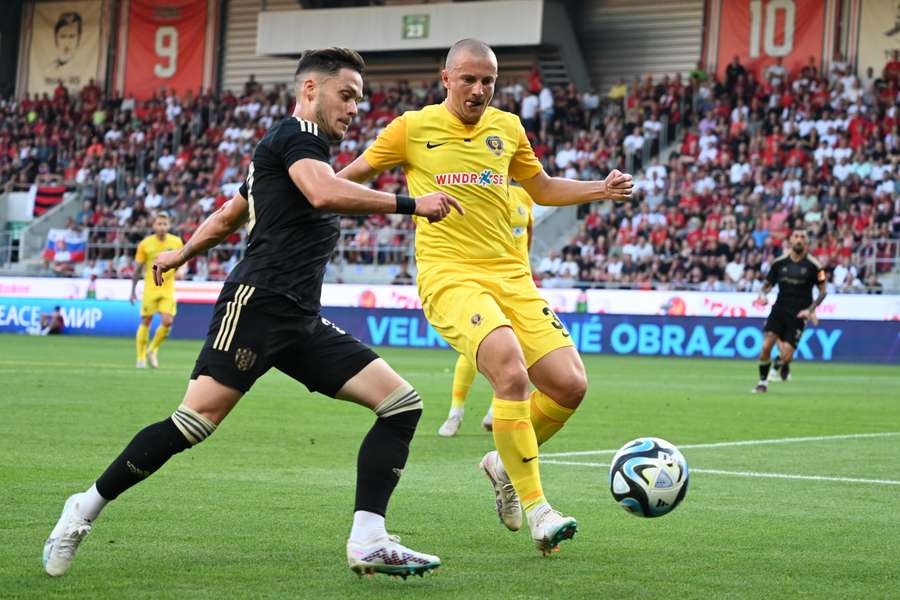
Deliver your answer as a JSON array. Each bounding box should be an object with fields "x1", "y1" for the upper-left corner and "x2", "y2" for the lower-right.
[{"x1": 419, "y1": 265, "x2": 574, "y2": 367}]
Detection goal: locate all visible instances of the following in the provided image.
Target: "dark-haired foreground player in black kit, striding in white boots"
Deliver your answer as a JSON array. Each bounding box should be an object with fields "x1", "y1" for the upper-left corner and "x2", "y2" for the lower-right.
[{"x1": 43, "y1": 48, "x2": 463, "y2": 578}]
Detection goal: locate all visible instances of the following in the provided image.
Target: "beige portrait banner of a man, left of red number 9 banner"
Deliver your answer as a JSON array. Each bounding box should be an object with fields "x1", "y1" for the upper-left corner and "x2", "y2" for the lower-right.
[{"x1": 28, "y1": 1, "x2": 103, "y2": 94}]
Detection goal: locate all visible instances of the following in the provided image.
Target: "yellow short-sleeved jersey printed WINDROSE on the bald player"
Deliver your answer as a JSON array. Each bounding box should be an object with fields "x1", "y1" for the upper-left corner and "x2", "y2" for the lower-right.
[{"x1": 364, "y1": 104, "x2": 543, "y2": 271}]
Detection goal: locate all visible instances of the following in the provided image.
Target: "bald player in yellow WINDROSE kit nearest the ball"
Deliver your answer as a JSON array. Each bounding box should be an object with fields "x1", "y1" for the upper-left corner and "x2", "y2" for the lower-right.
[{"x1": 339, "y1": 39, "x2": 633, "y2": 554}]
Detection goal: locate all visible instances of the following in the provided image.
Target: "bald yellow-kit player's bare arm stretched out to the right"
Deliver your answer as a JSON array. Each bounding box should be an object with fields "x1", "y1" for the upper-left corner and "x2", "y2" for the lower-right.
[{"x1": 519, "y1": 169, "x2": 634, "y2": 206}]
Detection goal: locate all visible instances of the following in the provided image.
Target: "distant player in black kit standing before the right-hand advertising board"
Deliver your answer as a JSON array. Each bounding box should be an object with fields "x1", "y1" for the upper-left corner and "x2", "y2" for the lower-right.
[{"x1": 753, "y1": 229, "x2": 826, "y2": 393}]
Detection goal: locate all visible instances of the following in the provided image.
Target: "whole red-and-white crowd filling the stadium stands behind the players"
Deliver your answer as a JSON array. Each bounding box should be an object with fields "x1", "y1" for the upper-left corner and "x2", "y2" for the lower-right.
[{"x1": 0, "y1": 53, "x2": 900, "y2": 290}]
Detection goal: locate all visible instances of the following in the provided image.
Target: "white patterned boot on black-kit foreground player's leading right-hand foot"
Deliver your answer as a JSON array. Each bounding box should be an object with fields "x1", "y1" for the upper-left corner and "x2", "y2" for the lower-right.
[{"x1": 347, "y1": 535, "x2": 441, "y2": 579}]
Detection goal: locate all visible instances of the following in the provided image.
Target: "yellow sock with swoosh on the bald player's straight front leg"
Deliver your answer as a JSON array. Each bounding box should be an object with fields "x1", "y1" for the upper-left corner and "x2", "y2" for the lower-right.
[{"x1": 492, "y1": 396, "x2": 546, "y2": 512}]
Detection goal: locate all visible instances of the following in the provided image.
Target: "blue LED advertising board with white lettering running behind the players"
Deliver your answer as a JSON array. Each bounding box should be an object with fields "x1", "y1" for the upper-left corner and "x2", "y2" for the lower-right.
[{"x1": 0, "y1": 297, "x2": 900, "y2": 364}]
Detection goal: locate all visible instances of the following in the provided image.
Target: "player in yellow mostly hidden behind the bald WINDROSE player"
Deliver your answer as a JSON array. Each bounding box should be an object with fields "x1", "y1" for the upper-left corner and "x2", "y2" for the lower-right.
[{"x1": 438, "y1": 185, "x2": 534, "y2": 437}]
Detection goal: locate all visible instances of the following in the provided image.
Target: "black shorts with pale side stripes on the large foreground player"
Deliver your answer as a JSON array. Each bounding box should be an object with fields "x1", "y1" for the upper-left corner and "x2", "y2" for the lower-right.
[{"x1": 191, "y1": 283, "x2": 378, "y2": 397}]
